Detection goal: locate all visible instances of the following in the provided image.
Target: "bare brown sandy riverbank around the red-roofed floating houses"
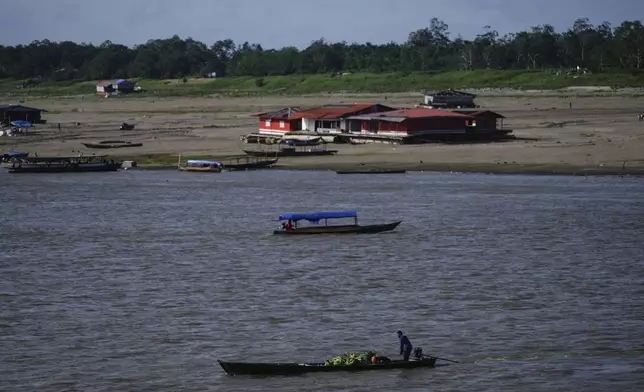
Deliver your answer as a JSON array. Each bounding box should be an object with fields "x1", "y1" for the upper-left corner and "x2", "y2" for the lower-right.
[{"x1": 0, "y1": 91, "x2": 644, "y2": 174}]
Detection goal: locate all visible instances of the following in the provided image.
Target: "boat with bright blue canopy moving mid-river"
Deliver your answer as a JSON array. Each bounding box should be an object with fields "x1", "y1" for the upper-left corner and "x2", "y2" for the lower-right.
[{"x1": 273, "y1": 211, "x2": 402, "y2": 234}]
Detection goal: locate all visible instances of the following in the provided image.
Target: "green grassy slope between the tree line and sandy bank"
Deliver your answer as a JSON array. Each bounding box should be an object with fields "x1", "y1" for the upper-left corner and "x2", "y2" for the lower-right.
[{"x1": 0, "y1": 70, "x2": 644, "y2": 96}]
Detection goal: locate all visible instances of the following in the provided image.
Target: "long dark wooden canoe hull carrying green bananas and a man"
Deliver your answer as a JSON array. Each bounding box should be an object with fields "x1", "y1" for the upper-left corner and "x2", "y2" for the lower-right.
[{"x1": 217, "y1": 357, "x2": 436, "y2": 376}]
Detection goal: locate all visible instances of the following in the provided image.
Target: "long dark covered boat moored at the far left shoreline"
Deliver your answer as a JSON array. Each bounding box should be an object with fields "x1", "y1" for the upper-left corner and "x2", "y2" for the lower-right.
[{"x1": 2, "y1": 155, "x2": 121, "y2": 173}]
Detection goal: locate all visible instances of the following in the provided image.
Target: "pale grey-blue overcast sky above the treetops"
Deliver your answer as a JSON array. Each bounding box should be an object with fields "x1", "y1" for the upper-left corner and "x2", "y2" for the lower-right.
[{"x1": 0, "y1": 0, "x2": 644, "y2": 48}]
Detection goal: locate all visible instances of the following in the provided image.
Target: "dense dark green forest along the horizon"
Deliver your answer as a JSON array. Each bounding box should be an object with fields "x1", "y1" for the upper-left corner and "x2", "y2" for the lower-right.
[{"x1": 0, "y1": 18, "x2": 644, "y2": 80}]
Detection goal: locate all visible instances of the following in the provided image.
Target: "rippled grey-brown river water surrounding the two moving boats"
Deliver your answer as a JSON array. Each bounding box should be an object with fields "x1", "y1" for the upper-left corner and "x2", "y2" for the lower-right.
[{"x1": 0, "y1": 171, "x2": 644, "y2": 391}]
